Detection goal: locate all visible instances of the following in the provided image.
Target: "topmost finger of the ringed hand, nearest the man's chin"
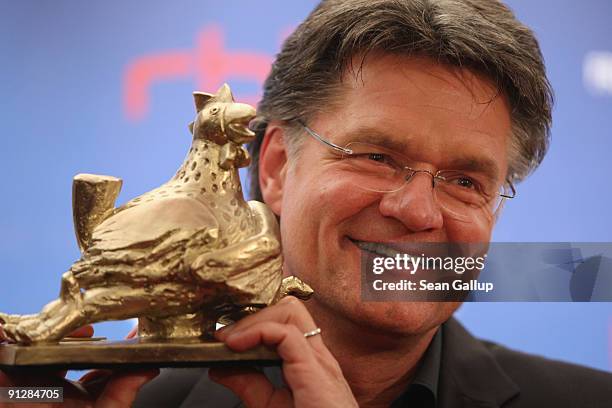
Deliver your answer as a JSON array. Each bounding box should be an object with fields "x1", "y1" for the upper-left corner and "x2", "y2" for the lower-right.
[{"x1": 215, "y1": 296, "x2": 317, "y2": 341}]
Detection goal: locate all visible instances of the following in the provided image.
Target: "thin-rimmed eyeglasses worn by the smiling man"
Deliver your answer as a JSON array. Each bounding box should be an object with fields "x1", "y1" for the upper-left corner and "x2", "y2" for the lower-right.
[{"x1": 298, "y1": 121, "x2": 516, "y2": 221}]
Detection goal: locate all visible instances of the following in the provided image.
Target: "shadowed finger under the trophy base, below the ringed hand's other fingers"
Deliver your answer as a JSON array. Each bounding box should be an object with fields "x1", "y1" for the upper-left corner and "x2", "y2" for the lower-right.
[{"x1": 208, "y1": 367, "x2": 293, "y2": 408}]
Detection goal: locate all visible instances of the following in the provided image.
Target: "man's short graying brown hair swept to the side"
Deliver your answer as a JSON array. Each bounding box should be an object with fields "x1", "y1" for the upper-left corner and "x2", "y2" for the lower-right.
[{"x1": 249, "y1": 0, "x2": 553, "y2": 200}]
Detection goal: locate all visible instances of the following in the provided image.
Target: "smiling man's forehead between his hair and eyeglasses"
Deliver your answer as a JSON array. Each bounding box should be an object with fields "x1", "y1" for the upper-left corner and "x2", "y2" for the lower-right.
[{"x1": 315, "y1": 55, "x2": 511, "y2": 172}]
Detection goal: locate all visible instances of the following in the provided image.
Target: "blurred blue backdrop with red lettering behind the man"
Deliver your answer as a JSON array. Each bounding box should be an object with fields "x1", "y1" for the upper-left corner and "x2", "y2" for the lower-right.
[{"x1": 0, "y1": 0, "x2": 612, "y2": 370}]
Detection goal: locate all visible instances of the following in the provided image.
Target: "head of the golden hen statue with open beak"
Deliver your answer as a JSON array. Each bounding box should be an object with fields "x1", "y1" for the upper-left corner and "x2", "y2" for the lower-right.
[{"x1": 190, "y1": 84, "x2": 255, "y2": 147}]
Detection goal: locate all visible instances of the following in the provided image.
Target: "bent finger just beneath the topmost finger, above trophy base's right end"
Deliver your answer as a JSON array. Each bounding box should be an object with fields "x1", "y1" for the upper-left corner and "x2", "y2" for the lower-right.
[{"x1": 225, "y1": 322, "x2": 314, "y2": 363}]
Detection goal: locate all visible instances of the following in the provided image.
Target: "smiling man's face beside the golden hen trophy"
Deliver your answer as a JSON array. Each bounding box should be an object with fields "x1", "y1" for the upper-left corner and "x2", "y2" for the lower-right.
[{"x1": 266, "y1": 55, "x2": 511, "y2": 334}]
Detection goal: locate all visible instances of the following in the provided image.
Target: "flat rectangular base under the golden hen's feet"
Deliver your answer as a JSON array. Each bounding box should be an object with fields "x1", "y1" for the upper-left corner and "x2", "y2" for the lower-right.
[{"x1": 0, "y1": 338, "x2": 282, "y2": 371}]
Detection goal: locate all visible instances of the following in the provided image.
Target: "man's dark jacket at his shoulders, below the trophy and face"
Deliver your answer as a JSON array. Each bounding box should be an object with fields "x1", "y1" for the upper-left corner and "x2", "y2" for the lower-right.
[{"x1": 135, "y1": 319, "x2": 612, "y2": 408}]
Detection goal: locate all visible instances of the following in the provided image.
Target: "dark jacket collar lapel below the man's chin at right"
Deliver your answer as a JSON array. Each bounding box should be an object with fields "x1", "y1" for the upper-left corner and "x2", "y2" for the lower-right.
[{"x1": 438, "y1": 318, "x2": 519, "y2": 408}]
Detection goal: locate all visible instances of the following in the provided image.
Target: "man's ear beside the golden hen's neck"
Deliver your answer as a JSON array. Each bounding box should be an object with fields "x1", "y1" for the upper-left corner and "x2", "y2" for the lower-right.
[{"x1": 259, "y1": 123, "x2": 287, "y2": 216}]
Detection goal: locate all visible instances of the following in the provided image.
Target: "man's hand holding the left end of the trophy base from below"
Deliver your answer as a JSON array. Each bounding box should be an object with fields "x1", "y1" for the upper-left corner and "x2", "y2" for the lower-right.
[{"x1": 0, "y1": 326, "x2": 158, "y2": 408}]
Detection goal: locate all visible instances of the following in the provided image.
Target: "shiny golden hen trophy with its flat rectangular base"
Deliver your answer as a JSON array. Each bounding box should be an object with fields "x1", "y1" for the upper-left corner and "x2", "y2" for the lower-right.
[{"x1": 0, "y1": 85, "x2": 312, "y2": 369}]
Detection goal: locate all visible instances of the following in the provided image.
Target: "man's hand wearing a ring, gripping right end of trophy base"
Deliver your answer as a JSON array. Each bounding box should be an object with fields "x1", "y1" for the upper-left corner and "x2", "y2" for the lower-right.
[{"x1": 209, "y1": 296, "x2": 357, "y2": 408}]
